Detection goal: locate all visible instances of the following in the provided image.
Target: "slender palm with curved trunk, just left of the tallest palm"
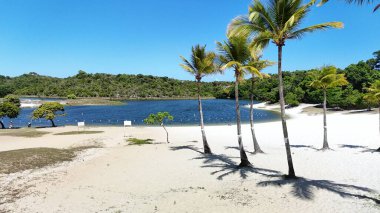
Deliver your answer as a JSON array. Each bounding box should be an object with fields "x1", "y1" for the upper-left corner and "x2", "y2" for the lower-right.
[{"x1": 248, "y1": 51, "x2": 274, "y2": 154}]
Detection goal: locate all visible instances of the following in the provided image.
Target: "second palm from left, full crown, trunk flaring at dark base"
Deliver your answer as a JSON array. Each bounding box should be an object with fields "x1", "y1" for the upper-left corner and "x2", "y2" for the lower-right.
[{"x1": 216, "y1": 36, "x2": 260, "y2": 167}]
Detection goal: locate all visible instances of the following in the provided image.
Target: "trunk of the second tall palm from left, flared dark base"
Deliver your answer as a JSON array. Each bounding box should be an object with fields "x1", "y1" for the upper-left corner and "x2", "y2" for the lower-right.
[{"x1": 235, "y1": 71, "x2": 252, "y2": 167}]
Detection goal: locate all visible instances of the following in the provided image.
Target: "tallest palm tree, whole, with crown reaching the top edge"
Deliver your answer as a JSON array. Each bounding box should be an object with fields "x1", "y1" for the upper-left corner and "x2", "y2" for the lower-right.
[{"x1": 228, "y1": 0, "x2": 343, "y2": 178}]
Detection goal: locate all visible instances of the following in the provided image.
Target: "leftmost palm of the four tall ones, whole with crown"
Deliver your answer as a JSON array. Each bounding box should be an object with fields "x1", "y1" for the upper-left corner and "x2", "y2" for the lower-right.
[{"x1": 180, "y1": 45, "x2": 218, "y2": 154}]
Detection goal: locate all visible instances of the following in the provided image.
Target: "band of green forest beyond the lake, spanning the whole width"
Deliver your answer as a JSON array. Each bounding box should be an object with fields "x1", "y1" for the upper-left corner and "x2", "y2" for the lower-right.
[{"x1": 0, "y1": 51, "x2": 380, "y2": 109}]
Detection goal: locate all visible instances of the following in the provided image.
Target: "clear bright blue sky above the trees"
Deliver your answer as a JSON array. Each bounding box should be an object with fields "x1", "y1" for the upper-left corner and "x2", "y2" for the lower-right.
[{"x1": 0, "y1": 0, "x2": 380, "y2": 81}]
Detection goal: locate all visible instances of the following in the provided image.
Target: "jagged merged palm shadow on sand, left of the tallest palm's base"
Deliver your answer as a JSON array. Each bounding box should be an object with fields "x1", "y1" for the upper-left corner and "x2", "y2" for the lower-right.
[{"x1": 170, "y1": 145, "x2": 281, "y2": 180}]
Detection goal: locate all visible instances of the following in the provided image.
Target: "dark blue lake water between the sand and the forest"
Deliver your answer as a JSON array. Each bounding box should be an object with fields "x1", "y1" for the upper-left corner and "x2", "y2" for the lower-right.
[{"x1": 3, "y1": 99, "x2": 279, "y2": 127}]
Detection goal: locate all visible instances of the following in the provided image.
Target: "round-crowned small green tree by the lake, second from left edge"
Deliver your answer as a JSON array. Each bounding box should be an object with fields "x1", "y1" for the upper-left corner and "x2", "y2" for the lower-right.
[{"x1": 32, "y1": 102, "x2": 66, "y2": 127}]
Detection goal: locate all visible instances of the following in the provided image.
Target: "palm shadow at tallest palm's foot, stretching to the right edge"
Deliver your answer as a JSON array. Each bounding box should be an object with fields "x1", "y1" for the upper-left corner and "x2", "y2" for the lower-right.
[{"x1": 257, "y1": 178, "x2": 380, "y2": 204}]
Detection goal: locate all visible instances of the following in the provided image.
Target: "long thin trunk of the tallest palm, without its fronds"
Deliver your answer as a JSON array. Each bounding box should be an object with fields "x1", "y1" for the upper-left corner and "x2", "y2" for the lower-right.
[{"x1": 278, "y1": 44, "x2": 296, "y2": 178}]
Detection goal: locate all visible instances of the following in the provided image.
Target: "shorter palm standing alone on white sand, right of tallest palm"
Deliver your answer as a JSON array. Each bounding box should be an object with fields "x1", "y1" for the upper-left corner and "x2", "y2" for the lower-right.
[{"x1": 310, "y1": 66, "x2": 348, "y2": 150}]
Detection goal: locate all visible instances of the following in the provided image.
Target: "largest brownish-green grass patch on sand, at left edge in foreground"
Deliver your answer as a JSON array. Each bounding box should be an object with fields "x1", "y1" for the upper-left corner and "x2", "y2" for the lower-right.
[{"x1": 0, "y1": 146, "x2": 97, "y2": 174}]
